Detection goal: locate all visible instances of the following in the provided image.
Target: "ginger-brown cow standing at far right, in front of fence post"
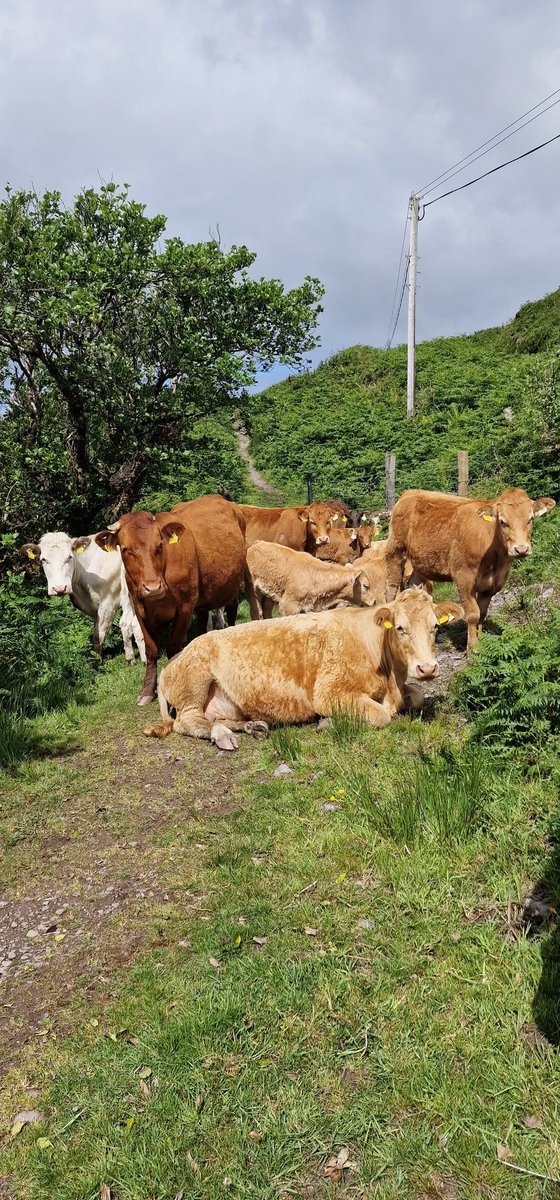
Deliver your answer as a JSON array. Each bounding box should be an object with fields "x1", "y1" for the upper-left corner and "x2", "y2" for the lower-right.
[{"x1": 386, "y1": 487, "x2": 555, "y2": 646}]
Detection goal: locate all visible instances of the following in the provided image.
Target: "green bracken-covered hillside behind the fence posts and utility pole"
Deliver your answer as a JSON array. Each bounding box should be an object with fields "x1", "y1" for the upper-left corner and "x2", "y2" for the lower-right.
[{"x1": 248, "y1": 290, "x2": 560, "y2": 505}]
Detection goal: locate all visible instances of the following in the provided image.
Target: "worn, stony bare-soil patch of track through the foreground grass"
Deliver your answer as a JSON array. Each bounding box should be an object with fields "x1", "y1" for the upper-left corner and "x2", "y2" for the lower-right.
[{"x1": 0, "y1": 733, "x2": 251, "y2": 1073}]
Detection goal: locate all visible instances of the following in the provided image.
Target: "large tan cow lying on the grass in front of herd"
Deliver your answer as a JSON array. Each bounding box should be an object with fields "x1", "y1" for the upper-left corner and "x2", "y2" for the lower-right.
[{"x1": 144, "y1": 588, "x2": 463, "y2": 750}]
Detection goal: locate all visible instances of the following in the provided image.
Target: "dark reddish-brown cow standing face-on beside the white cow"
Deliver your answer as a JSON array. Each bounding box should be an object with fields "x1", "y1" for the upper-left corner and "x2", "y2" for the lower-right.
[{"x1": 95, "y1": 496, "x2": 258, "y2": 704}]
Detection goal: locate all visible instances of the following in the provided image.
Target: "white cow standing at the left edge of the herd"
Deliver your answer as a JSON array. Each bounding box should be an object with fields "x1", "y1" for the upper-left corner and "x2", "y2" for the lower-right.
[{"x1": 22, "y1": 530, "x2": 146, "y2": 662}]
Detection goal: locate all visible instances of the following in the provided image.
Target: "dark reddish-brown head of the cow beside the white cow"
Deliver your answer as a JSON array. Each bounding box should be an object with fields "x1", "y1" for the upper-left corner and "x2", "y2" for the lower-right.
[{"x1": 95, "y1": 512, "x2": 185, "y2": 600}]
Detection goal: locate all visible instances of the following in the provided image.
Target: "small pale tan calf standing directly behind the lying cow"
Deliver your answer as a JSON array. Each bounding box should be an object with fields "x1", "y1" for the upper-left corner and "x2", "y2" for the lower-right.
[{"x1": 247, "y1": 541, "x2": 369, "y2": 618}]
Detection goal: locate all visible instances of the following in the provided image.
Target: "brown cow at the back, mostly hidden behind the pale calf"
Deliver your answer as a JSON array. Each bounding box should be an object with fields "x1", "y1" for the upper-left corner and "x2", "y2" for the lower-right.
[{"x1": 236, "y1": 504, "x2": 341, "y2": 554}]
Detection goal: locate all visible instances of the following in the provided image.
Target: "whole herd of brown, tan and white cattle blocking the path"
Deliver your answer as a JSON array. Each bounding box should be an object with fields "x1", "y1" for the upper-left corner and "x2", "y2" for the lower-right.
[{"x1": 23, "y1": 488, "x2": 555, "y2": 750}]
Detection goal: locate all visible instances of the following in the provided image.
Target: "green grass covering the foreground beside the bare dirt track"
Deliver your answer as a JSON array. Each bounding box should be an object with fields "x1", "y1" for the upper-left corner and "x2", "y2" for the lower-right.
[{"x1": 4, "y1": 664, "x2": 560, "y2": 1200}]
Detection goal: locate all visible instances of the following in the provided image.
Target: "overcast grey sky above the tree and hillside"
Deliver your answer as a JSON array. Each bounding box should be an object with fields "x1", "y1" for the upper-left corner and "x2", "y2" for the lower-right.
[{"x1": 0, "y1": 0, "x2": 560, "y2": 376}]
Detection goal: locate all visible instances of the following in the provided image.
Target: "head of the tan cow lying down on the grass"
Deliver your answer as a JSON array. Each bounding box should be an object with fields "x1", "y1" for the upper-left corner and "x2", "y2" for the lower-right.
[{"x1": 373, "y1": 588, "x2": 463, "y2": 679}]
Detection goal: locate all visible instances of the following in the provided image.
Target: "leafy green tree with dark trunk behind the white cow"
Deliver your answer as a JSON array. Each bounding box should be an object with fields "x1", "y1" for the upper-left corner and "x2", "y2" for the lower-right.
[{"x1": 0, "y1": 184, "x2": 323, "y2": 535}]
